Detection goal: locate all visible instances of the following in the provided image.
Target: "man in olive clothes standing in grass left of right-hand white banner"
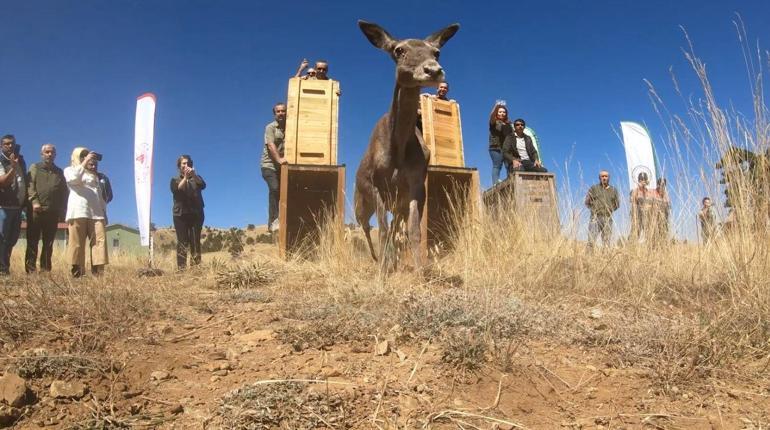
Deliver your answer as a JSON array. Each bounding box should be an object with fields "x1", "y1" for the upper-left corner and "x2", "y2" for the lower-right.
[{"x1": 585, "y1": 170, "x2": 620, "y2": 248}]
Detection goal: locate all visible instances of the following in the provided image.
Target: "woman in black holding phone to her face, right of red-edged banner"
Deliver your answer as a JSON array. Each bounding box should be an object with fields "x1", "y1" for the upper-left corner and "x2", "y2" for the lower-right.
[{"x1": 171, "y1": 154, "x2": 206, "y2": 270}]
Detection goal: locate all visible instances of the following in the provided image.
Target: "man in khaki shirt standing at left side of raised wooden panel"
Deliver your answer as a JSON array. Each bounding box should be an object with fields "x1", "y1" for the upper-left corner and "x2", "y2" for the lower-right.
[{"x1": 261, "y1": 103, "x2": 288, "y2": 233}]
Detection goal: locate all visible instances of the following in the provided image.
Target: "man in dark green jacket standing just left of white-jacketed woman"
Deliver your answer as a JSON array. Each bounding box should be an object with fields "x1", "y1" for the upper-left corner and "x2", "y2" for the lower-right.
[{"x1": 24, "y1": 143, "x2": 69, "y2": 273}]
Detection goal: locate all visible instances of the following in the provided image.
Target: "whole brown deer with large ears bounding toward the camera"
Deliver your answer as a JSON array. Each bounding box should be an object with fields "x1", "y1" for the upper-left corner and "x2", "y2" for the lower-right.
[{"x1": 355, "y1": 21, "x2": 460, "y2": 268}]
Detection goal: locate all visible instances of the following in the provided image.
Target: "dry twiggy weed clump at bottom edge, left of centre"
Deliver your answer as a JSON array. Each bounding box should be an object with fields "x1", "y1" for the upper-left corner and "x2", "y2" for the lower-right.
[{"x1": 219, "y1": 381, "x2": 353, "y2": 429}]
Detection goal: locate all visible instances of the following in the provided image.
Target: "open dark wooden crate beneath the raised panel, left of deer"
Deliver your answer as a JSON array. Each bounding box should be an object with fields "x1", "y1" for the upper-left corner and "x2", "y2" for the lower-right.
[{"x1": 278, "y1": 164, "x2": 345, "y2": 258}]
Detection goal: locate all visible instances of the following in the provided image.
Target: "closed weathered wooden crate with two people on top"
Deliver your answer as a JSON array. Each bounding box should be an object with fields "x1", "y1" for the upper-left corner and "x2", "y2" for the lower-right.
[{"x1": 483, "y1": 171, "x2": 560, "y2": 234}]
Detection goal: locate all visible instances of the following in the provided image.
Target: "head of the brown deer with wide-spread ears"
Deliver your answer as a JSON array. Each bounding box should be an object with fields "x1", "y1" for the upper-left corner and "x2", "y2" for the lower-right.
[{"x1": 358, "y1": 20, "x2": 460, "y2": 88}]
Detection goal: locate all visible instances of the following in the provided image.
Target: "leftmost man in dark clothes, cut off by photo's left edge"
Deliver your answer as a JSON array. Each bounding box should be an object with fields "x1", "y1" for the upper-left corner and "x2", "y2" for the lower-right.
[{"x1": 0, "y1": 134, "x2": 27, "y2": 275}]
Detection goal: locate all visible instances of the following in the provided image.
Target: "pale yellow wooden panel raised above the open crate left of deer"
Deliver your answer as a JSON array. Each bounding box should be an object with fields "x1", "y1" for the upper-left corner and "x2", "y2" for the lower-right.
[{"x1": 284, "y1": 78, "x2": 340, "y2": 166}]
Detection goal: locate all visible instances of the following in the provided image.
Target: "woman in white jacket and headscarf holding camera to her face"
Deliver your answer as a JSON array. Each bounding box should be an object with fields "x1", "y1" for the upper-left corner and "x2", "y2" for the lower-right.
[{"x1": 64, "y1": 147, "x2": 109, "y2": 278}]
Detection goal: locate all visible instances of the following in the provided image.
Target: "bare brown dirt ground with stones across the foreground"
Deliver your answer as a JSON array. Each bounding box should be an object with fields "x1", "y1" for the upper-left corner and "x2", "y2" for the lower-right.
[{"x1": 3, "y1": 240, "x2": 770, "y2": 429}]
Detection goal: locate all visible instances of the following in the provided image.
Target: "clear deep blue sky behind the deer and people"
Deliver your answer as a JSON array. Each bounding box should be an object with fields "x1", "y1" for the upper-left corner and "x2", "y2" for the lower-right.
[{"x1": 0, "y1": 0, "x2": 770, "y2": 239}]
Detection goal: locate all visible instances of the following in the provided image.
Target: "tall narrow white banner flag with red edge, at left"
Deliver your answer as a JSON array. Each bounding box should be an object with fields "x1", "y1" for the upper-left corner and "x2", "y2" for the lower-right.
[{"x1": 134, "y1": 93, "x2": 155, "y2": 246}]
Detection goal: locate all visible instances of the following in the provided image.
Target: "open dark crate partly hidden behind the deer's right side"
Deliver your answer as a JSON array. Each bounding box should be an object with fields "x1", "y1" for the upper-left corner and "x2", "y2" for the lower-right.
[{"x1": 420, "y1": 166, "x2": 481, "y2": 257}]
